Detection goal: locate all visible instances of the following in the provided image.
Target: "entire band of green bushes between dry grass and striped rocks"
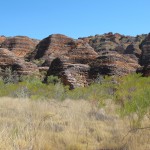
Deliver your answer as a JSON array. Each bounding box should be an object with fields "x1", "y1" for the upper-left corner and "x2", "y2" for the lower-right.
[{"x1": 0, "y1": 69, "x2": 150, "y2": 126}]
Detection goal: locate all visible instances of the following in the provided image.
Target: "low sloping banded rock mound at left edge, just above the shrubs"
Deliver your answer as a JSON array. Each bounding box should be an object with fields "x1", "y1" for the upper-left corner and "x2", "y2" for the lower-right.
[{"x1": 0, "y1": 48, "x2": 39, "y2": 75}]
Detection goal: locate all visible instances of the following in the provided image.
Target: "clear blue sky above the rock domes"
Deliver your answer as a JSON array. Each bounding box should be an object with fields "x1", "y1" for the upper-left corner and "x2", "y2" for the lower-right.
[{"x1": 0, "y1": 0, "x2": 150, "y2": 39}]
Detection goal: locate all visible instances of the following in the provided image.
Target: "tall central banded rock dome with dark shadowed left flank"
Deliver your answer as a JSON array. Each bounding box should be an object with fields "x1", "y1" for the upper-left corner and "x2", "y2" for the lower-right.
[{"x1": 30, "y1": 34, "x2": 97, "y2": 66}]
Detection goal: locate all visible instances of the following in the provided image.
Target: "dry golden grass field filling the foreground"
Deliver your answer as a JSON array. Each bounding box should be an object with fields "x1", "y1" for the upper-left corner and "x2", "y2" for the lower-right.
[{"x1": 0, "y1": 98, "x2": 150, "y2": 150}]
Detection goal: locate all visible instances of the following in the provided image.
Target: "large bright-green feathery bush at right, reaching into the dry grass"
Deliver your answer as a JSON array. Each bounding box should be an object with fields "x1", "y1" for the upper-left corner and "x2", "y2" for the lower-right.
[{"x1": 115, "y1": 74, "x2": 150, "y2": 125}]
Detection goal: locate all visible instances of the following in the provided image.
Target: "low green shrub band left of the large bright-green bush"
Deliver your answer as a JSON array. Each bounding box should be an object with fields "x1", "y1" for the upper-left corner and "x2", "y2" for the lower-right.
[{"x1": 0, "y1": 72, "x2": 115, "y2": 105}]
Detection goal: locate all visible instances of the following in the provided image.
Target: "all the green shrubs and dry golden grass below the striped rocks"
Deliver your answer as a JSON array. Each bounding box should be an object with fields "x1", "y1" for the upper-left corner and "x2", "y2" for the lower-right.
[{"x1": 0, "y1": 69, "x2": 150, "y2": 150}]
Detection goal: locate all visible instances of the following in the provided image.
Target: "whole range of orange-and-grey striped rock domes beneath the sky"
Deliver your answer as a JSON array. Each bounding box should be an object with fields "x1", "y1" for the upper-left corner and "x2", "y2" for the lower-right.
[{"x1": 0, "y1": 33, "x2": 150, "y2": 88}]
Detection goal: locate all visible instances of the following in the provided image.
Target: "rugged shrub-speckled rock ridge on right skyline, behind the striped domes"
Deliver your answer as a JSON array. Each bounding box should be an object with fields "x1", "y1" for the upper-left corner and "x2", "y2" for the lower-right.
[{"x1": 80, "y1": 32, "x2": 146, "y2": 58}]
